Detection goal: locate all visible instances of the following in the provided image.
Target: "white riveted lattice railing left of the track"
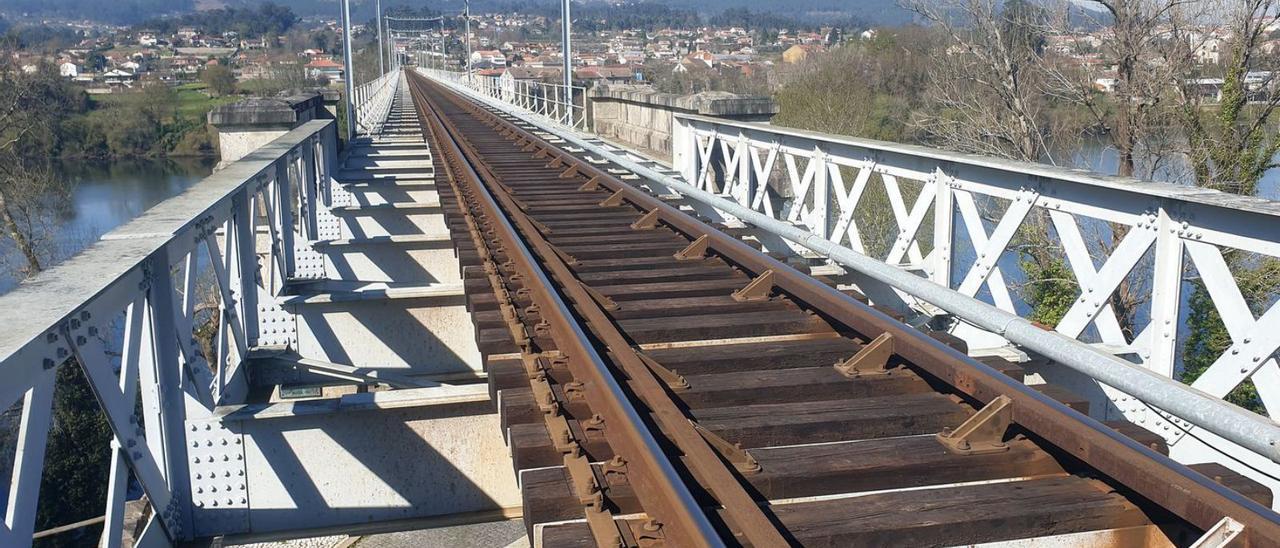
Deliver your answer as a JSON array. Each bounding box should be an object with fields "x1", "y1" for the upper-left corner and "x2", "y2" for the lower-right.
[{"x1": 0, "y1": 120, "x2": 337, "y2": 547}]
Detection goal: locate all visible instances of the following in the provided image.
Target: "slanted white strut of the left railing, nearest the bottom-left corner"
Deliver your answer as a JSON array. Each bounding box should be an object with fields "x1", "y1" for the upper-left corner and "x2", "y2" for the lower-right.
[{"x1": 0, "y1": 375, "x2": 58, "y2": 545}]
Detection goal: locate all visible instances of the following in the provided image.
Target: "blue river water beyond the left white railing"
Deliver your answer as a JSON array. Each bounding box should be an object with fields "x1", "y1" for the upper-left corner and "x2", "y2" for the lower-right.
[{"x1": 0, "y1": 159, "x2": 215, "y2": 294}]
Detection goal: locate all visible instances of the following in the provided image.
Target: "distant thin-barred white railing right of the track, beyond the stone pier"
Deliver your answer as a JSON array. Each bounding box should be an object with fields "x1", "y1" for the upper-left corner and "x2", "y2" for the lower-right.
[{"x1": 417, "y1": 68, "x2": 588, "y2": 131}]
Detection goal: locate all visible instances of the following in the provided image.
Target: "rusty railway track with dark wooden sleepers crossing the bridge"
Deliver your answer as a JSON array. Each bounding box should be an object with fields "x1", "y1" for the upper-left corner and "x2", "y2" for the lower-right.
[{"x1": 410, "y1": 70, "x2": 1280, "y2": 547}]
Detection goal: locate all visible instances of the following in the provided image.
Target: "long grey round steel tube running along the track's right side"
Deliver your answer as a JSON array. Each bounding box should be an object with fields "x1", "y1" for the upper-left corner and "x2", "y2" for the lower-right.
[{"x1": 419, "y1": 66, "x2": 1280, "y2": 462}]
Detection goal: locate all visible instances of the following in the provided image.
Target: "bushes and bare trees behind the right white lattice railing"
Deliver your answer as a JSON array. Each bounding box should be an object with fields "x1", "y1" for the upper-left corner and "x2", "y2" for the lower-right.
[{"x1": 773, "y1": 0, "x2": 1280, "y2": 414}]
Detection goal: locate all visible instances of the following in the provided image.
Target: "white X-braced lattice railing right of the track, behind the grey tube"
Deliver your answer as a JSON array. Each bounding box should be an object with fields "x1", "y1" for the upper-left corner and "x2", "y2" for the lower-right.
[{"x1": 672, "y1": 114, "x2": 1280, "y2": 476}]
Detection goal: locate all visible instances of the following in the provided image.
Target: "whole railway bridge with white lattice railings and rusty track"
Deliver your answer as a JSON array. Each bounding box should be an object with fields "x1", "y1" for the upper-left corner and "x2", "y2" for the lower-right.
[{"x1": 0, "y1": 68, "x2": 1280, "y2": 547}]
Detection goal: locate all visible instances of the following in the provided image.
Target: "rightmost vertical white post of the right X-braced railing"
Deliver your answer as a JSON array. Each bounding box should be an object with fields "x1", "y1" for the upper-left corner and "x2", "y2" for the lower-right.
[{"x1": 1146, "y1": 207, "x2": 1183, "y2": 378}]
